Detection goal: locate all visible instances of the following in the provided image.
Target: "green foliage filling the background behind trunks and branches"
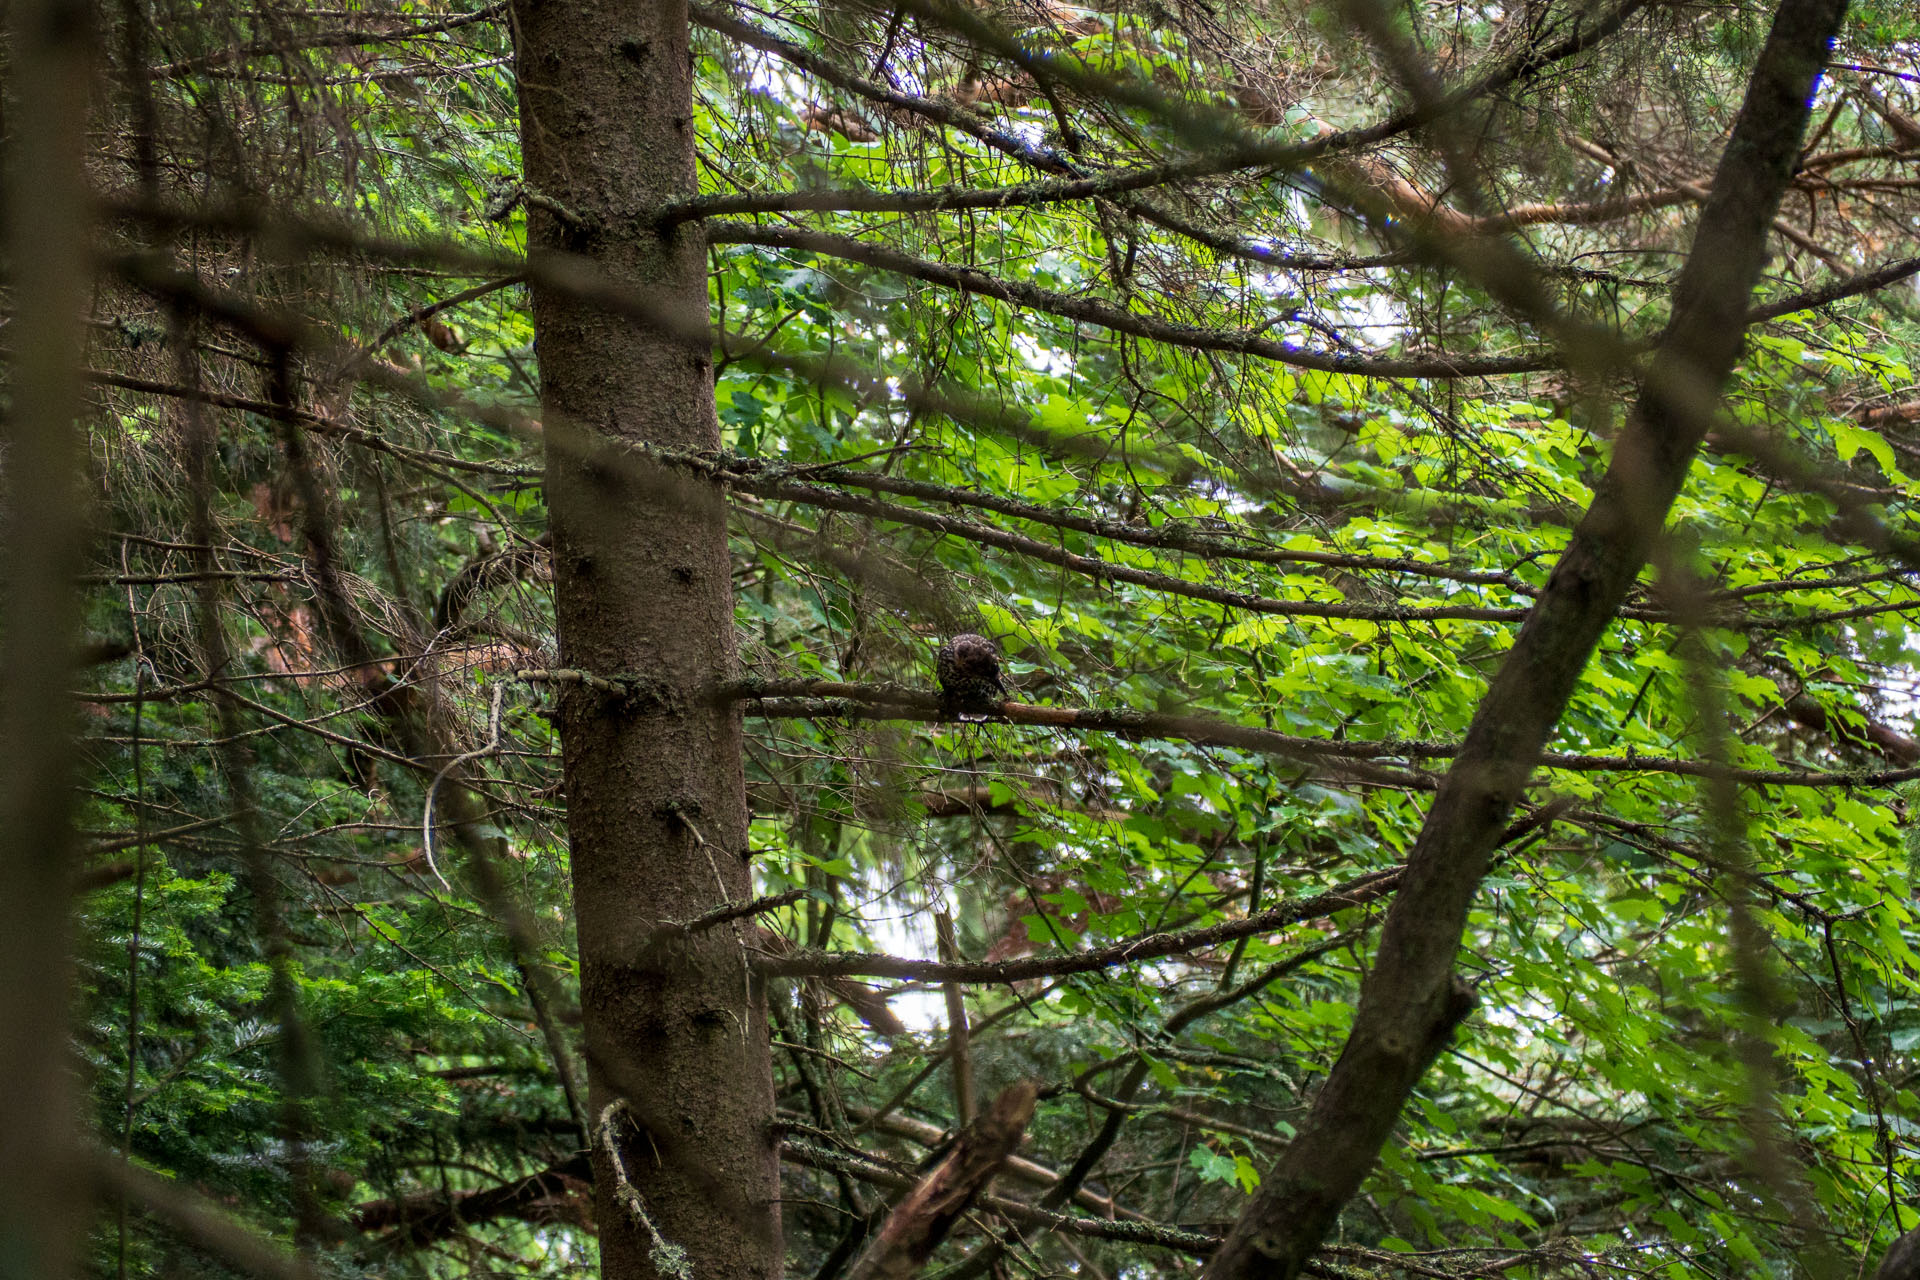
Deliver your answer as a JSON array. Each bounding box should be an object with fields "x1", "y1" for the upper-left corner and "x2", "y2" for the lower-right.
[{"x1": 75, "y1": 0, "x2": 1920, "y2": 1276}]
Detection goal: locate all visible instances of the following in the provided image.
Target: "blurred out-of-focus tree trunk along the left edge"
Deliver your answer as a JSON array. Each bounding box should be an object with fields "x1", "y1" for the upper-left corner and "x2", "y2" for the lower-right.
[{"x1": 0, "y1": 0, "x2": 92, "y2": 1280}]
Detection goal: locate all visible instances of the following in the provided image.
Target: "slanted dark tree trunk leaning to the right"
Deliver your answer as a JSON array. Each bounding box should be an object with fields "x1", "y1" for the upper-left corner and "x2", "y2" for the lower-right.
[{"x1": 1206, "y1": 0, "x2": 1847, "y2": 1280}]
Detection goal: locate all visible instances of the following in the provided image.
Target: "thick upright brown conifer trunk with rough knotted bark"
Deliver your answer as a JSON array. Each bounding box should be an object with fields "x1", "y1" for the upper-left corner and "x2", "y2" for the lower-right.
[{"x1": 513, "y1": 0, "x2": 781, "y2": 1280}]
